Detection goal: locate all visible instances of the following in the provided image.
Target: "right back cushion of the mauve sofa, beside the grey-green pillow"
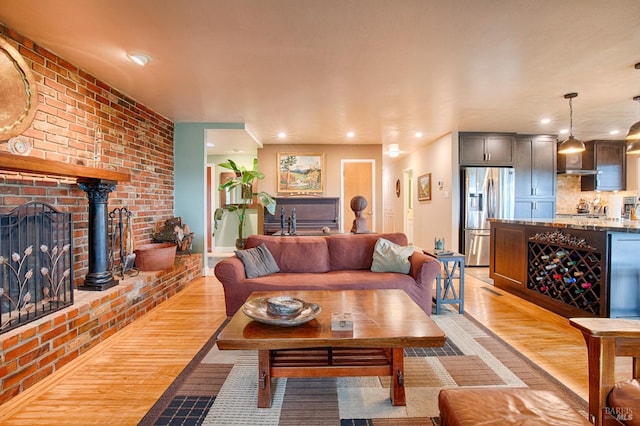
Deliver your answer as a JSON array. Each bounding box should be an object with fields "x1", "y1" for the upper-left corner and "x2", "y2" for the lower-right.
[{"x1": 328, "y1": 232, "x2": 407, "y2": 271}]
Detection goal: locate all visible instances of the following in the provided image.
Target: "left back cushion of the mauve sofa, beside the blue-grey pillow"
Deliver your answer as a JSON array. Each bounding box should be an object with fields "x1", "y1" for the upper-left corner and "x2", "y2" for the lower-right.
[{"x1": 246, "y1": 235, "x2": 330, "y2": 272}]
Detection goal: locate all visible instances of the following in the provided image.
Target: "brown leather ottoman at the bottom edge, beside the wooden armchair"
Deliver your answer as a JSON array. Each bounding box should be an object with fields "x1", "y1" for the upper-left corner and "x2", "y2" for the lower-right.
[{"x1": 438, "y1": 388, "x2": 591, "y2": 426}]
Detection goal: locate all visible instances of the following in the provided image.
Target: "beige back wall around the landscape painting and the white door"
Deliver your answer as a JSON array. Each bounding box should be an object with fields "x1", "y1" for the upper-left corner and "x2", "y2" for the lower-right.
[{"x1": 258, "y1": 144, "x2": 383, "y2": 231}]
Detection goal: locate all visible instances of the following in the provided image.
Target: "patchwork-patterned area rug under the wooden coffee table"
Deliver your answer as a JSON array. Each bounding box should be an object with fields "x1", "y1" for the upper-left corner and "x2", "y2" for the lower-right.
[{"x1": 140, "y1": 309, "x2": 587, "y2": 426}]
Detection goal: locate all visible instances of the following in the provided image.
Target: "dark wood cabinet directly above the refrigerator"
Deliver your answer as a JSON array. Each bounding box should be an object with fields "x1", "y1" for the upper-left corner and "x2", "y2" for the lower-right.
[{"x1": 459, "y1": 133, "x2": 516, "y2": 166}]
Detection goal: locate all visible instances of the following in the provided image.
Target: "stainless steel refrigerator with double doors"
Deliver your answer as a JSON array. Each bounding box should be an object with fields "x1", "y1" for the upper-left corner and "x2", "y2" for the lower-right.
[{"x1": 462, "y1": 167, "x2": 515, "y2": 266}]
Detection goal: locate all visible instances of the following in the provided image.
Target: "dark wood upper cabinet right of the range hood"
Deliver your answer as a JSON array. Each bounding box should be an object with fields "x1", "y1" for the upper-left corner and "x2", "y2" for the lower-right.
[{"x1": 581, "y1": 141, "x2": 627, "y2": 191}]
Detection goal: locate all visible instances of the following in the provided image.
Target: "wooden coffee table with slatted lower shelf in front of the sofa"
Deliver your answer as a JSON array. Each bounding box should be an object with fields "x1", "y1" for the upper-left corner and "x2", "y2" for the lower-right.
[{"x1": 217, "y1": 290, "x2": 445, "y2": 408}]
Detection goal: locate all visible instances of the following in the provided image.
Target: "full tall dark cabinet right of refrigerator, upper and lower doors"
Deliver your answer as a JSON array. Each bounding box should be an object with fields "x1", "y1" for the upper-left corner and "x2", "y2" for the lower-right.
[{"x1": 514, "y1": 135, "x2": 557, "y2": 219}]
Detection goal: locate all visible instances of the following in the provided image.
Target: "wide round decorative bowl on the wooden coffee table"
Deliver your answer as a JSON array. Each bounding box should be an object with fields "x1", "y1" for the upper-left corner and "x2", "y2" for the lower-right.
[{"x1": 242, "y1": 296, "x2": 320, "y2": 327}]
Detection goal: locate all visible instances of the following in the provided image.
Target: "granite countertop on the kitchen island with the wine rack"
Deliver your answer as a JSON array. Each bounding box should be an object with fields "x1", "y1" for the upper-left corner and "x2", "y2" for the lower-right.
[{"x1": 489, "y1": 217, "x2": 640, "y2": 234}]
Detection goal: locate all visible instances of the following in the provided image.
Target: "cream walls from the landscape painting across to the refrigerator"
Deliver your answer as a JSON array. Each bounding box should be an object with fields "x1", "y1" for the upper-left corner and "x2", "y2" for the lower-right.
[{"x1": 258, "y1": 138, "x2": 460, "y2": 250}]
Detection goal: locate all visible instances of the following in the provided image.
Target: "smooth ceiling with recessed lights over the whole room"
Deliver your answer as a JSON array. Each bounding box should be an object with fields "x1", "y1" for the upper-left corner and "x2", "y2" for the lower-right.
[{"x1": 0, "y1": 0, "x2": 640, "y2": 156}]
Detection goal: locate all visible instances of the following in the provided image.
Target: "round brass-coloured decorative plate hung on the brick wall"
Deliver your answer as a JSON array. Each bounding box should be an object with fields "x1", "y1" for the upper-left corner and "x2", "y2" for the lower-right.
[{"x1": 0, "y1": 37, "x2": 38, "y2": 141}]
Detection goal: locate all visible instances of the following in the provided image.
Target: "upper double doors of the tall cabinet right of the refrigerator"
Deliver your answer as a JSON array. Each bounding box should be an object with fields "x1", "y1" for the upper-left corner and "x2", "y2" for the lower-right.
[{"x1": 514, "y1": 135, "x2": 557, "y2": 198}]
